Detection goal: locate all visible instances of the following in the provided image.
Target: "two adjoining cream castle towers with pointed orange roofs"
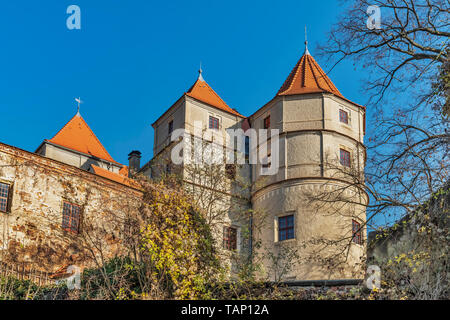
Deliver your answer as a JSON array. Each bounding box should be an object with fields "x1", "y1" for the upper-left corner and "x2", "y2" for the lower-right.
[{"x1": 140, "y1": 47, "x2": 368, "y2": 280}]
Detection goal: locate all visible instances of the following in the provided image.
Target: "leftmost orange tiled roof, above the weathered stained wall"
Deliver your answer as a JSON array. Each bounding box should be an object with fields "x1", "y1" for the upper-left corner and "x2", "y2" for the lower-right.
[{"x1": 48, "y1": 114, "x2": 117, "y2": 163}]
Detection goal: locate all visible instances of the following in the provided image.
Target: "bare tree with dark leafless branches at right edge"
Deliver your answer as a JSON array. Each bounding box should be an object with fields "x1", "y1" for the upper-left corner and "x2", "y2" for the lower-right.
[{"x1": 319, "y1": 0, "x2": 450, "y2": 226}]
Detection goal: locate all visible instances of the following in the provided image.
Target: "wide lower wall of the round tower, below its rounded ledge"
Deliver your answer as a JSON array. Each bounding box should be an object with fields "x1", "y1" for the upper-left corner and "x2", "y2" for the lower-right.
[{"x1": 252, "y1": 180, "x2": 366, "y2": 281}]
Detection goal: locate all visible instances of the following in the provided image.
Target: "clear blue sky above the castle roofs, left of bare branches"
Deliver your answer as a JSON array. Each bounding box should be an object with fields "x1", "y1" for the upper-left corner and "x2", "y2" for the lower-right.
[{"x1": 0, "y1": 0, "x2": 366, "y2": 164}]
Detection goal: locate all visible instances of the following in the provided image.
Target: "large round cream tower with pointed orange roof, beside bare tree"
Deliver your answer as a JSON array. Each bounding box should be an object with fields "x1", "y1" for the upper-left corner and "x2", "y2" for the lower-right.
[{"x1": 250, "y1": 48, "x2": 367, "y2": 281}]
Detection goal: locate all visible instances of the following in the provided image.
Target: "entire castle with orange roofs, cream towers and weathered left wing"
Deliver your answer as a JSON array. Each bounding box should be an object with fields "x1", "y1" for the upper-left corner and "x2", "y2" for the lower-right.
[{"x1": 0, "y1": 43, "x2": 368, "y2": 281}]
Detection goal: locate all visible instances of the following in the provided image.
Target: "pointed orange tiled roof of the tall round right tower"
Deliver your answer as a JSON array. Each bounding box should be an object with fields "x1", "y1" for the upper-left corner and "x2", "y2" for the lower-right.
[{"x1": 277, "y1": 52, "x2": 343, "y2": 98}]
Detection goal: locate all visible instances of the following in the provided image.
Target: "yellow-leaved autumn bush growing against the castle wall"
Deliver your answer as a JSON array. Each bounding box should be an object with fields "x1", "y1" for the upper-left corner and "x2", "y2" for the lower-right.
[{"x1": 140, "y1": 182, "x2": 220, "y2": 299}]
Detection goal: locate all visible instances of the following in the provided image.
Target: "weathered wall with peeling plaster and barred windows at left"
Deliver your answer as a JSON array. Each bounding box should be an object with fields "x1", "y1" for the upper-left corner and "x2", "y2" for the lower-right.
[{"x1": 0, "y1": 144, "x2": 140, "y2": 272}]
